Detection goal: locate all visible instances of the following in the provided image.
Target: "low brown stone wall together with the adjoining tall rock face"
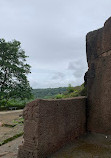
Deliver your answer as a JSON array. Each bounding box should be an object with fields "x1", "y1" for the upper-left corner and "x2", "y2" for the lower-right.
[{"x1": 18, "y1": 18, "x2": 111, "y2": 158}]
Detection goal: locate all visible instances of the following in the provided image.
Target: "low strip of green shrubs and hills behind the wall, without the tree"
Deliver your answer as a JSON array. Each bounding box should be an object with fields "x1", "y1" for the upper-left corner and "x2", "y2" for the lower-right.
[{"x1": 0, "y1": 84, "x2": 86, "y2": 111}]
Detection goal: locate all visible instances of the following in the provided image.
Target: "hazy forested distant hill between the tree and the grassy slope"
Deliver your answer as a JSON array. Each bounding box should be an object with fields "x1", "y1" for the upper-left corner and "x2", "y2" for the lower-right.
[{"x1": 32, "y1": 87, "x2": 67, "y2": 99}]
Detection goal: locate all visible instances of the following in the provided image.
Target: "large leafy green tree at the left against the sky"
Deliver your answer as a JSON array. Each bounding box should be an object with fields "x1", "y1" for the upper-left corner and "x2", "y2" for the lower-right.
[{"x1": 0, "y1": 39, "x2": 32, "y2": 100}]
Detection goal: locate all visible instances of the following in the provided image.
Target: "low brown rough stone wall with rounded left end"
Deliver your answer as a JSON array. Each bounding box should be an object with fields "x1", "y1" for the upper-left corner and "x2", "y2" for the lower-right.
[{"x1": 18, "y1": 97, "x2": 86, "y2": 158}]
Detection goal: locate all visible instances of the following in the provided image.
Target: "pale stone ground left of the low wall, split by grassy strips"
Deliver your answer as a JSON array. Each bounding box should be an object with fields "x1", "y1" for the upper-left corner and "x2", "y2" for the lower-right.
[{"x1": 0, "y1": 110, "x2": 23, "y2": 158}]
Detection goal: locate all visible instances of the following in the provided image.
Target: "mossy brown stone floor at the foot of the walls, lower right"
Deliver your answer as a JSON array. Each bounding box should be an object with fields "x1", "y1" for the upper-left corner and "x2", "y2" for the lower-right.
[{"x1": 50, "y1": 134, "x2": 111, "y2": 158}]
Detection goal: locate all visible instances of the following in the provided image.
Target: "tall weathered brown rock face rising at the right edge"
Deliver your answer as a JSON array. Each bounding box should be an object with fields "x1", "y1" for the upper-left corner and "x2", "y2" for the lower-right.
[{"x1": 86, "y1": 18, "x2": 111, "y2": 134}]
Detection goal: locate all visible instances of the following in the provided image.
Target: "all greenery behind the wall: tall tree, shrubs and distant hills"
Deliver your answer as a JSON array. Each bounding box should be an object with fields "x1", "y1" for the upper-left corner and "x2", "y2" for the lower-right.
[{"x1": 0, "y1": 39, "x2": 86, "y2": 110}]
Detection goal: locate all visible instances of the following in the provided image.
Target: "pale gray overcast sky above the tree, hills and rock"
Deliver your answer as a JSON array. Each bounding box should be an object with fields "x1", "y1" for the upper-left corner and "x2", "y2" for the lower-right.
[{"x1": 0, "y1": 0, "x2": 111, "y2": 88}]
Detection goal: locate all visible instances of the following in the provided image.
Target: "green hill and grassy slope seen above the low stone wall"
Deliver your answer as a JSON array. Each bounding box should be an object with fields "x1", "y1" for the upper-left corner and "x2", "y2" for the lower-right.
[{"x1": 32, "y1": 84, "x2": 86, "y2": 99}]
